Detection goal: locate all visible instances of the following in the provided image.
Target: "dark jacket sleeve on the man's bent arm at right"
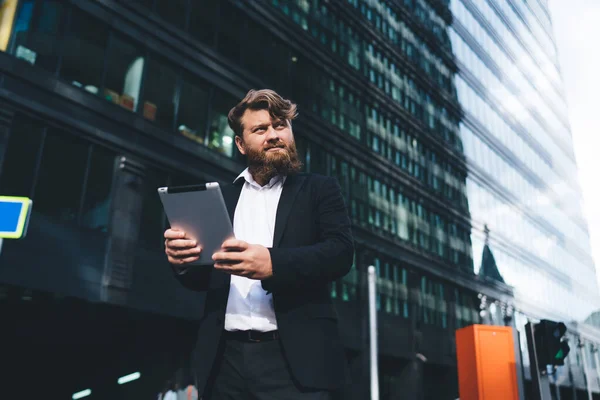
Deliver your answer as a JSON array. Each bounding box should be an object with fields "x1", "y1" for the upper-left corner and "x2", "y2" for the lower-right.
[{"x1": 262, "y1": 177, "x2": 354, "y2": 292}]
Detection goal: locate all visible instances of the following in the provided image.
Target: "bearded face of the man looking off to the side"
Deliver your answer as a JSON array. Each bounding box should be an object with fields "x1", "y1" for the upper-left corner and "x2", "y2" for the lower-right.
[{"x1": 235, "y1": 110, "x2": 298, "y2": 175}]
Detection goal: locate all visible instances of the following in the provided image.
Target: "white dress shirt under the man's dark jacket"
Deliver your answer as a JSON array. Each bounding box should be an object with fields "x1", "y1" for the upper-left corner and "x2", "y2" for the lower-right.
[{"x1": 225, "y1": 168, "x2": 285, "y2": 332}]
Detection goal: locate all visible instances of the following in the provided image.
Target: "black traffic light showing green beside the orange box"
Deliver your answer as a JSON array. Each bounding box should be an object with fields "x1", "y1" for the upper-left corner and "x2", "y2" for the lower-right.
[{"x1": 533, "y1": 319, "x2": 570, "y2": 369}]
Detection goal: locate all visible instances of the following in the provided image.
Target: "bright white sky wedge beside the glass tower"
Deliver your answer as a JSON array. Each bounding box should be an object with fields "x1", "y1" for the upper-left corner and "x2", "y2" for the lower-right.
[{"x1": 549, "y1": 0, "x2": 600, "y2": 292}]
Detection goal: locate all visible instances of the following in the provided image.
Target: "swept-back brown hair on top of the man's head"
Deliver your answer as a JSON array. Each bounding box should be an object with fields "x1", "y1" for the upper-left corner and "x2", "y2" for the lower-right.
[{"x1": 227, "y1": 89, "x2": 298, "y2": 136}]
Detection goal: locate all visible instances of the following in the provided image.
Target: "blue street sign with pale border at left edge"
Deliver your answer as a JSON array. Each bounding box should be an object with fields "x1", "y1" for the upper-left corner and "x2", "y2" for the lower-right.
[{"x1": 0, "y1": 196, "x2": 32, "y2": 239}]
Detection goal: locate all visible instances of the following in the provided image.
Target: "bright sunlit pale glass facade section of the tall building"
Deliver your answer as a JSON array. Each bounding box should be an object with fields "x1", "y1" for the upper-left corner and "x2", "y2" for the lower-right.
[{"x1": 450, "y1": 0, "x2": 599, "y2": 321}]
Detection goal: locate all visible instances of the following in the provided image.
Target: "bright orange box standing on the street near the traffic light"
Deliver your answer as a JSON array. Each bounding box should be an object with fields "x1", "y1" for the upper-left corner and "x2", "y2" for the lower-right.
[{"x1": 456, "y1": 325, "x2": 519, "y2": 400}]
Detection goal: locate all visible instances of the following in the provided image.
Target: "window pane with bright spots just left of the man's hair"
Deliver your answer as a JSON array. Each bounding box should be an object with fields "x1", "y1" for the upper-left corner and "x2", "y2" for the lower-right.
[{"x1": 208, "y1": 89, "x2": 238, "y2": 157}]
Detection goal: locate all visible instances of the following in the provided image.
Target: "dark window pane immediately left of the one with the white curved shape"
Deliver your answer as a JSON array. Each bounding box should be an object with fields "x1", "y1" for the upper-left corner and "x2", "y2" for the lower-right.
[{"x1": 60, "y1": 9, "x2": 108, "y2": 94}]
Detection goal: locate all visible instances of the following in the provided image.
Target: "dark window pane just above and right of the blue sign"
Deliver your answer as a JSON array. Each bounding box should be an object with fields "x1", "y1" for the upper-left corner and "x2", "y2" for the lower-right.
[{"x1": 33, "y1": 129, "x2": 89, "y2": 222}]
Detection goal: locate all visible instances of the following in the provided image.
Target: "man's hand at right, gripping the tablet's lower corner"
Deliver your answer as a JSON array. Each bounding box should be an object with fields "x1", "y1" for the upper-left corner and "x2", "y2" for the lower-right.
[{"x1": 212, "y1": 239, "x2": 273, "y2": 280}]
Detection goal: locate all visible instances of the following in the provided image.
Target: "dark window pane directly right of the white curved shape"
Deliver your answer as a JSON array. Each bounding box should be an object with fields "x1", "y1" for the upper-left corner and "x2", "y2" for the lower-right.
[{"x1": 144, "y1": 57, "x2": 177, "y2": 131}]
